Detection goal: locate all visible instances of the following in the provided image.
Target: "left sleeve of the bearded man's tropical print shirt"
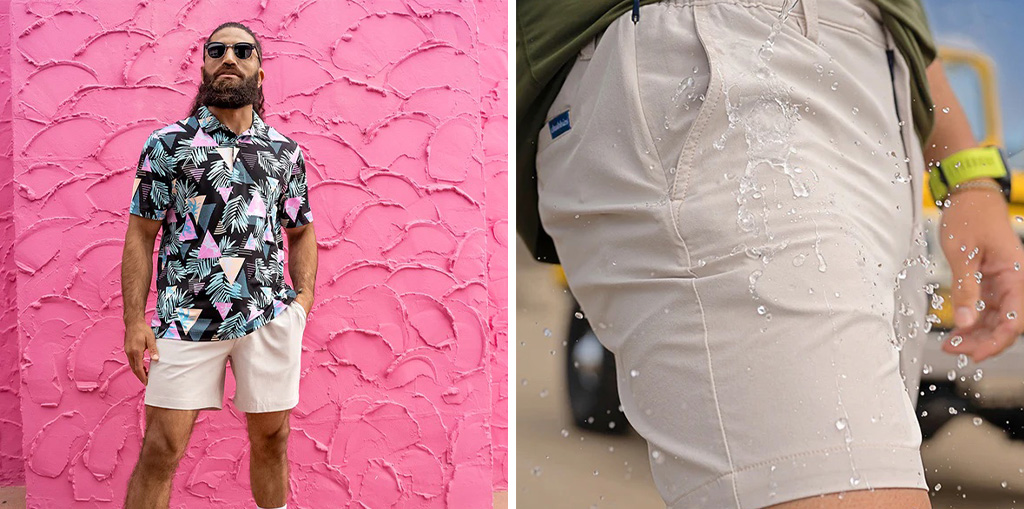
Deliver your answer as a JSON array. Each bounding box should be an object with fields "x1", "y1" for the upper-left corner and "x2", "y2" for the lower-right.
[{"x1": 129, "y1": 133, "x2": 172, "y2": 220}]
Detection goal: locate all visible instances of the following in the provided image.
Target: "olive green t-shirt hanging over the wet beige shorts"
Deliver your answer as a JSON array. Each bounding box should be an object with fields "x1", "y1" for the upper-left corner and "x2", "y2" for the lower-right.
[{"x1": 515, "y1": 0, "x2": 936, "y2": 263}]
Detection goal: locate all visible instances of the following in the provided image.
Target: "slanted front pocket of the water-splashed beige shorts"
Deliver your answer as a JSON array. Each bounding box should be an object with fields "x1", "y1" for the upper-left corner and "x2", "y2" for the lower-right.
[{"x1": 634, "y1": 3, "x2": 723, "y2": 200}]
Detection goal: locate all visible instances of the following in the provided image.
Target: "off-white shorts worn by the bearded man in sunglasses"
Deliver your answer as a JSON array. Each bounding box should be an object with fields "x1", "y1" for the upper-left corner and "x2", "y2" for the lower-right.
[{"x1": 145, "y1": 301, "x2": 306, "y2": 413}]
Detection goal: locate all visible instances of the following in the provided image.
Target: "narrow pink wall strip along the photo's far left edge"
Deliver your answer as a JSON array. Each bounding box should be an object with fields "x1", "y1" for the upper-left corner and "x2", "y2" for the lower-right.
[{"x1": 0, "y1": 1, "x2": 25, "y2": 486}]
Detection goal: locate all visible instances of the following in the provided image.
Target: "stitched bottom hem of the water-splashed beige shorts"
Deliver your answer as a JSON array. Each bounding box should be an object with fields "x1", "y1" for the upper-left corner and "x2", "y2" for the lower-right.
[{"x1": 668, "y1": 444, "x2": 928, "y2": 509}]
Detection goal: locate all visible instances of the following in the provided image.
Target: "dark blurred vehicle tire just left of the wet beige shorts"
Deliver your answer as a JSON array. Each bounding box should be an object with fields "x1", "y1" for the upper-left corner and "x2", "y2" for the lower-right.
[{"x1": 565, "y1": 304, "x2": 629, "y2": 434}]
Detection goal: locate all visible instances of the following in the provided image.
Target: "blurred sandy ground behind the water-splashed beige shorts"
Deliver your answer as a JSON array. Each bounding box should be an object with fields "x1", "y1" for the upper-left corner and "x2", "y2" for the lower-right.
[{"x1": 514, "y1": 238, "x2": 1024, "y2": 509}]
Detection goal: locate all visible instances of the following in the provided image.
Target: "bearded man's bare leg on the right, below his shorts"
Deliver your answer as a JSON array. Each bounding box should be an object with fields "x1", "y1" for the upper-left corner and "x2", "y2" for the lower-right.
[{"x1": 246, "y1": 410, "x2": 292, "y2": 507}]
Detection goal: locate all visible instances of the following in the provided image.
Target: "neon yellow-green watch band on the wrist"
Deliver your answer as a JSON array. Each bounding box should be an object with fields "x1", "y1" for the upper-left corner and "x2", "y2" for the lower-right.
[{"x1": 928, "y1": 146, "x2": 1011, "y2": 207}]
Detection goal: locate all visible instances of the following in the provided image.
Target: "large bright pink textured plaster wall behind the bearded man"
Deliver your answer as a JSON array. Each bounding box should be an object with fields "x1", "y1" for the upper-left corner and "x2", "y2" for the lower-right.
[{"x1": 8, "y1": 0, "x2": 508, "y2": 509}]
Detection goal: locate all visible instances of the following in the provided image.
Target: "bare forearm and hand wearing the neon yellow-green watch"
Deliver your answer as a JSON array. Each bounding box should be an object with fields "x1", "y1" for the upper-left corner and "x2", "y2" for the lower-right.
[{"x1": 925, "y1": 59, "x2": 1024, "y2": 362}]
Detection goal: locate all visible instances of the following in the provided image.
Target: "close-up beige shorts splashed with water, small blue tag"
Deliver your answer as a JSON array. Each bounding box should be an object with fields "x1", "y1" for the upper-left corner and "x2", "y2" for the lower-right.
[{"x1": 538, "y1": 0, "x2": 927, "y2": 503}]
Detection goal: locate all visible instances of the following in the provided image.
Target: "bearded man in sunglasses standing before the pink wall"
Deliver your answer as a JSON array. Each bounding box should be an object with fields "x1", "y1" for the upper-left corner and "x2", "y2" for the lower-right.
[{"x1": 121, "y1": 23, "x2": 316, "y2": 509}]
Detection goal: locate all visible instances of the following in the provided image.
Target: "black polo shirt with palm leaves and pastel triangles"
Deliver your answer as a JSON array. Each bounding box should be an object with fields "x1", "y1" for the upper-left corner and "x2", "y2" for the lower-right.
[{"x1": 130, "y1": 107, "x2": 313, "y2": 341}]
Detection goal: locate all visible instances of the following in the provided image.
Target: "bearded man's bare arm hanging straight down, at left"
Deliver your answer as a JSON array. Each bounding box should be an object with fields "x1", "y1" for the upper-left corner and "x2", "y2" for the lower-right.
[{"x1": 121, "y1": 214, "x2": 161, "y2": 385}]
